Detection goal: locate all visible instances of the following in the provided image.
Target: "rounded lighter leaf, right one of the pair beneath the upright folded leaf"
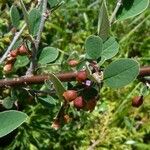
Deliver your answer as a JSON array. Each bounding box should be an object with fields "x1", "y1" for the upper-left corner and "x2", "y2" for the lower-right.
[{"x1": 101, "y1": 37, "x2": 119, "y2": 60}]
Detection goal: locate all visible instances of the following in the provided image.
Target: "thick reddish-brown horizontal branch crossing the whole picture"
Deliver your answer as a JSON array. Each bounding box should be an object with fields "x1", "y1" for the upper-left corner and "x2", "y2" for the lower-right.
[{"x1": 0, "y1": 66, "x2": 150, "y2": 87}]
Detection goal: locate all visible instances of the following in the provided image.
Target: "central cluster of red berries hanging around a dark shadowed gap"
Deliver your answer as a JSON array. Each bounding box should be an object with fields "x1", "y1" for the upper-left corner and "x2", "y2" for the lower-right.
[{"x1": 63, "y1": 71, "x2": 97, "y2": 111}]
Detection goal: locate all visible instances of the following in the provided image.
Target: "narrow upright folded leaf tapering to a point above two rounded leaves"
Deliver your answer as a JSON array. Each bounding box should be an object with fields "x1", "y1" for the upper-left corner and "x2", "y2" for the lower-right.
[{"x1": 98, "y1": 1, "x2": 110, "y2": 41}]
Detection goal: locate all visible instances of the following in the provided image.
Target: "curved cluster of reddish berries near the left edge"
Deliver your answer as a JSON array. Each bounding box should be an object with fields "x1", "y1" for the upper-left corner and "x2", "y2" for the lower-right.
[{"x1": 3, "y1": 44, "x2": 30, "y2": 73}]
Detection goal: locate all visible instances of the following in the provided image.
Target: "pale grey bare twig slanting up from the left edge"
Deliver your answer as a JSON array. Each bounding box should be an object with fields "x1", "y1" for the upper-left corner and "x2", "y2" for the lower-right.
[{"x1": 0, "y1": 24, "x2": 26, "y2": 64}]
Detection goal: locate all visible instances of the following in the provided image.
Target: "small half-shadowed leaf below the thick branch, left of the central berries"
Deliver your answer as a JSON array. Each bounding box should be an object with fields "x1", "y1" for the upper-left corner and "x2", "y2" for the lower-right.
[{"x1": 38, "y1": 96, "x2": 57, "y2": 108}]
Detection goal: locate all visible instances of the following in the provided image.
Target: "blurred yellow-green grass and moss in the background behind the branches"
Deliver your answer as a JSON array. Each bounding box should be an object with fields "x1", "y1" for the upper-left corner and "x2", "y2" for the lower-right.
[{"x1": 0, "y1": 0, "x2": 150, "y2": 150}]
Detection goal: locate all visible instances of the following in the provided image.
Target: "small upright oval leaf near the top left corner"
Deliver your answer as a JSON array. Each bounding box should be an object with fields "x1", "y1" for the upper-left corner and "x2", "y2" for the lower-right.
[{"x1": 10, "y1": 5, "x2": 20, "y2": 28}]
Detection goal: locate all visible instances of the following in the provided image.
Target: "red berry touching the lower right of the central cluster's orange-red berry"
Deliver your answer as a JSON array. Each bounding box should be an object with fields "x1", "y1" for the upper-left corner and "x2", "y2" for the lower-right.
[{"x1": 73, "y1": 96, "x2": 85, "y2": 109}]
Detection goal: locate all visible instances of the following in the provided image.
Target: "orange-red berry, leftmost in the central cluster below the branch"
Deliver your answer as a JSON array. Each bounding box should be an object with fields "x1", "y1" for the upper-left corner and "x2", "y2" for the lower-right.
[{"x1": 63, "y1": 90, "x2": 78, "y2": 102}]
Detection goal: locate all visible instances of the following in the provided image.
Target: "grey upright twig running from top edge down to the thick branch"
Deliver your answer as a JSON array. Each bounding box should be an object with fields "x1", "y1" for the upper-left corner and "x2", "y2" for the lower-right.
[{"x1": 26, "y1": 0, "x2": 47, "y2": 76}]
